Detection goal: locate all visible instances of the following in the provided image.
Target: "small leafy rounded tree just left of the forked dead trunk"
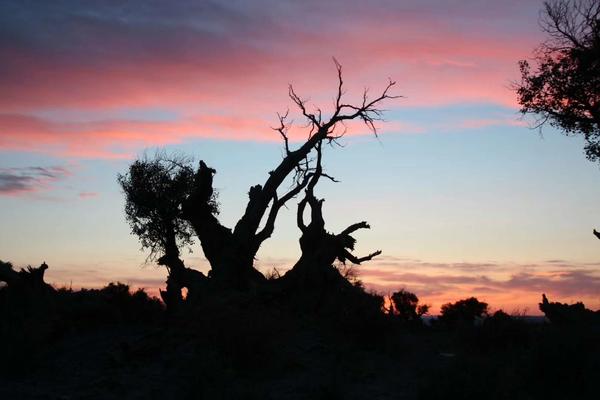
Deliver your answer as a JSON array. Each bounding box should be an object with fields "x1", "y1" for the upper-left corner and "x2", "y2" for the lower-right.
[{"x1": 118, "y1": 153, "x2": 210, "y2": 309}]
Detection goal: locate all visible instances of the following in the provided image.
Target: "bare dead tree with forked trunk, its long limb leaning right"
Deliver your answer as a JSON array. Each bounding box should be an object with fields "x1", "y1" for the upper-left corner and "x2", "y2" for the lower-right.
[{"x1": 183, "y1": 61, "x2": 398, "y2": 287}]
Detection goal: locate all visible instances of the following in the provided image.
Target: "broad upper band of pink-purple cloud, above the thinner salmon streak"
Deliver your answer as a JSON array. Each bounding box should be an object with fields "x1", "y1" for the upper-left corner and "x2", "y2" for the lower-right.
[{"x1": 0, "y1": 0, "x2": 536, "y2": 113}]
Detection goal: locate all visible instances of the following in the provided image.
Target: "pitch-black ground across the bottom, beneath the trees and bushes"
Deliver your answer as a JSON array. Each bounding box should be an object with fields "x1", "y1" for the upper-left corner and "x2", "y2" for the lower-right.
[{"x1": 0, "y1": 285, "x2": 600, "y2": 399}]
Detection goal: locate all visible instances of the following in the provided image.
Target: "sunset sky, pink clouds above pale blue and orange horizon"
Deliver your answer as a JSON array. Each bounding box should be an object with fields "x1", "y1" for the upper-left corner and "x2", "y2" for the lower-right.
[{"x1": 0, "y1": 0, "x2": 600, "y2": 314}]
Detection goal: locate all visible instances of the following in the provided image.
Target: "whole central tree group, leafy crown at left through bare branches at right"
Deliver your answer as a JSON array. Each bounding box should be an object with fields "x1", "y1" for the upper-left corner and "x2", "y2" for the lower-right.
[{"x1": 119, "y1": 60, "x2": 397, "y2": 300}]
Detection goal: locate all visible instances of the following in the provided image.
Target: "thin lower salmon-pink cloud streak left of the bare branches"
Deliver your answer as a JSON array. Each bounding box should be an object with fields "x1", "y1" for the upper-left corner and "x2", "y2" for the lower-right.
[{"x1": 0, "y1": 114, "x2": 277, "y2": 158}]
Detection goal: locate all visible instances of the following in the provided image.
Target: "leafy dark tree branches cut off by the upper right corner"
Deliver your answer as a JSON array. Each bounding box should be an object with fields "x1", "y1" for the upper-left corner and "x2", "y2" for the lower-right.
[{"x1": 516, "y1": 0, "x2": 600, "y2": 161}]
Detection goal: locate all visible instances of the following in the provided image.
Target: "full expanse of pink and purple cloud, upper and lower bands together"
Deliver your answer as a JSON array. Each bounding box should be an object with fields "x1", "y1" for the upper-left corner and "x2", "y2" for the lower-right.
[{"x1": 0, "y1": 1, "x2": 537, "y2": 158}]
